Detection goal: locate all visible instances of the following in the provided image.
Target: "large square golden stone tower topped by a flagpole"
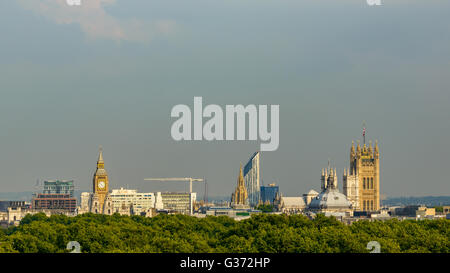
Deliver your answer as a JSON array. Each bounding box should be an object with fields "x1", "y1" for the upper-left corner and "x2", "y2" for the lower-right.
[{"x1": 344, "y1": 141, "x2": 380, "y2": 211}]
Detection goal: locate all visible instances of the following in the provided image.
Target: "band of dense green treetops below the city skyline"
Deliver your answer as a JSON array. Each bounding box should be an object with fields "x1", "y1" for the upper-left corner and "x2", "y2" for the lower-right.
[{"x1": 0, "y1": 214, "x2": 450, "y2": 253}]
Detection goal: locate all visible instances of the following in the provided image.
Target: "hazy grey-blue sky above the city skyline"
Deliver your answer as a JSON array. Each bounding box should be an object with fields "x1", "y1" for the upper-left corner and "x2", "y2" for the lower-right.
[{"x1": 0, "y1": 0, "x2": 450, "y2": 198}]
